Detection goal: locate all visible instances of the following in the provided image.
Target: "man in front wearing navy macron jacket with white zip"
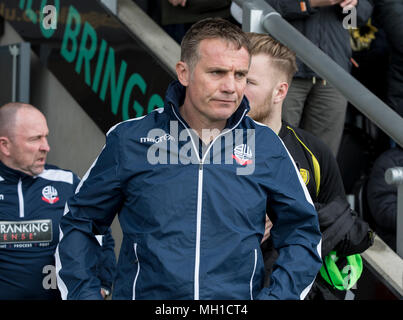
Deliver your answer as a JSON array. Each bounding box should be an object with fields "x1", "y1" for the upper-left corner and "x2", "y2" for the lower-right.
[{"x1": 57, "y1": 19, "x2": 321, "y2": 300}]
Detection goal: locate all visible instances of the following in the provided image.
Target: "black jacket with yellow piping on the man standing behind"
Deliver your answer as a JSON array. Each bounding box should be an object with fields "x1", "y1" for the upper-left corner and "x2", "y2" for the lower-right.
[{"x1": 261, "y1": 122, "x2": 373, "y2": 299}]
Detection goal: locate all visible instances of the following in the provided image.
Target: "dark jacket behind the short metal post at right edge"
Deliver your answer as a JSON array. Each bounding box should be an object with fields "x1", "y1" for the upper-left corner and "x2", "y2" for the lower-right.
[{"x1": 366, "y1": 147, "x2": 403, "y2": 250}]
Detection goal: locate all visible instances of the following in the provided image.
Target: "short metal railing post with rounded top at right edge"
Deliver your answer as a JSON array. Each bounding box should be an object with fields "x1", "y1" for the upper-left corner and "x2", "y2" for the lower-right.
[{"x1": 385, "y1": 167, "x2": 403, "y2": 259}]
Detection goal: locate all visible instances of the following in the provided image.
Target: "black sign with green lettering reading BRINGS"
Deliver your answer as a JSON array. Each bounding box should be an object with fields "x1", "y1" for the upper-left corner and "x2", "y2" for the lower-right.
[{"x1": 0, "y1": 0, "x2": 174, "y2": 132}]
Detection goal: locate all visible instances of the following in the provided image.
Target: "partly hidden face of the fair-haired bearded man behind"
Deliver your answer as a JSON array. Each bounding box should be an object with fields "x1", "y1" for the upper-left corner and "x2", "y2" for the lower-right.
[{"x1": 245, "y1": 54, "x2": 277, "y2": 123}]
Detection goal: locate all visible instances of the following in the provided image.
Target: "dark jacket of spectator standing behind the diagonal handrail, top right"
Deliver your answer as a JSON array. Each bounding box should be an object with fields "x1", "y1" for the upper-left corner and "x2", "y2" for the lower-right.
[{"x1": 265, "y1": 0, "x2": 373, "y2": 78}]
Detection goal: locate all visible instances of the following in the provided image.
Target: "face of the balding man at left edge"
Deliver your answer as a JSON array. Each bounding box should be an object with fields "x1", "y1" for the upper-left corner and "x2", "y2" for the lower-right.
[{"x1": 9, "y1": 108, "x2": 50, "y2": 176}]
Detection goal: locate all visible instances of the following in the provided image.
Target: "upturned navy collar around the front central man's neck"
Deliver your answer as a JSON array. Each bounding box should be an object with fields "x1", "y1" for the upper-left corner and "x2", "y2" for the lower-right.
[{"x1": 164, "y1": 80, "x2": 250, "y2": 128}]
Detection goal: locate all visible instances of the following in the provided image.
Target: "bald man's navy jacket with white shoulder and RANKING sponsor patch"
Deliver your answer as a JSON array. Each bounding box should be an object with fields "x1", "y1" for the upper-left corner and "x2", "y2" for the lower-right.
[{"x1": 0, "y1": 162, "x2": 116, "y2": 300}]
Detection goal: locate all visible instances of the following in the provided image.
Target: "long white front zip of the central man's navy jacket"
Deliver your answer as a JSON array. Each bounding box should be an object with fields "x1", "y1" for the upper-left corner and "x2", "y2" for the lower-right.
[{"x1": 171, "y1": 104, "x2": 247, "y2": 300}]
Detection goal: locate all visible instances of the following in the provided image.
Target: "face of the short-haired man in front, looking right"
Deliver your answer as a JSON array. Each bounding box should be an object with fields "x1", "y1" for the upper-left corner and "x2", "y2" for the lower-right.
[{"x1": 182, "y1": 39, "x2": 250, "y2": 127}]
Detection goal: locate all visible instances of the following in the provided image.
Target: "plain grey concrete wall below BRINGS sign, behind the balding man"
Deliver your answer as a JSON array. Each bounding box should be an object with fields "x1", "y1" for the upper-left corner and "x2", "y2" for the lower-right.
[{"x1": 0, "y1": 23, "x2": 122, "y2": 253}]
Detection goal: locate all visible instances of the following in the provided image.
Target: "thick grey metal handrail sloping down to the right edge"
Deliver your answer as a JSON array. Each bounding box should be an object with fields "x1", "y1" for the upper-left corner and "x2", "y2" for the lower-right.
[{"x1": 234, "y1": 0, "x2": 403, "y2": 147}]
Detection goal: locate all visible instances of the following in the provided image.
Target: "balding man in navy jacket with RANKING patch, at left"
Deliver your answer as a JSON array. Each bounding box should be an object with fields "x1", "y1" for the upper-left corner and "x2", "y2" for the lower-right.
[{"x1": 0, "y1": 104, "x2": 116, "y2": 300}]
